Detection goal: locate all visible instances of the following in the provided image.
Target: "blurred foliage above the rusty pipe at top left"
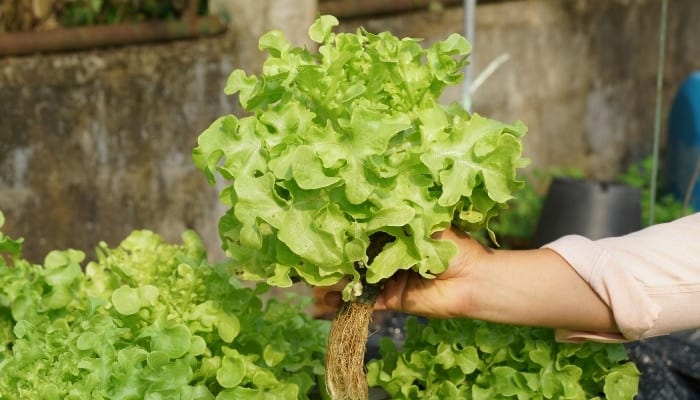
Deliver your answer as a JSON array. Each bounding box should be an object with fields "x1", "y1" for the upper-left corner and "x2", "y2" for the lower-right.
[{"x1": 0, "y1": 0, "x2": 207, "y2": 32}]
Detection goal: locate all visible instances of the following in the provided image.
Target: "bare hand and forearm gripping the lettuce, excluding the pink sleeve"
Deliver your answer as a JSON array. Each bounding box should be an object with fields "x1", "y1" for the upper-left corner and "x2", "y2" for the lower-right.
[{"x1": 325, "y1": 225, "x2": 618, "y2": 332}]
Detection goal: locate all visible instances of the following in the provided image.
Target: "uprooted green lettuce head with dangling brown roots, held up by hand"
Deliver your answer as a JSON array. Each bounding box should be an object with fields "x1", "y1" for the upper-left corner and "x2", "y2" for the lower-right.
[{"x1": 193, "y1": 16, "x2": 526, "y2": 398}]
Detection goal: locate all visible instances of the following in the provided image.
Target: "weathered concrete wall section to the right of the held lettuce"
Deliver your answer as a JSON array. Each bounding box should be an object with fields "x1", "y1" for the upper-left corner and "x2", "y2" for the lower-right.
[{"x1": 343, "y1": 0, "x2": 700, "y2": 179}]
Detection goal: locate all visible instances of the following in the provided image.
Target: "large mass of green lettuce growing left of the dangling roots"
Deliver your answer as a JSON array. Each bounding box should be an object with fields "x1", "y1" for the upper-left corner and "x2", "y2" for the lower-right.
[{"x1": 0, "y1": 213, "x2": 328, "y2": 400}]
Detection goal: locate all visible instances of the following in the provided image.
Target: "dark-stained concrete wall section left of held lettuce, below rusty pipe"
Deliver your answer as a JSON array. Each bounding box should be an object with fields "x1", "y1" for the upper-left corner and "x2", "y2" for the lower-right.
[{"x1": 0, "y1": 35, "x2": 236, "y2": 261}]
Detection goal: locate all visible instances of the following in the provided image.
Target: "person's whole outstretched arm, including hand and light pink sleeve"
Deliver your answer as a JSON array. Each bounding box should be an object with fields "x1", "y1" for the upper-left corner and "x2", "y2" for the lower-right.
[{"x1": 378, "y1": 213, "x2": 700, "y2": 341}]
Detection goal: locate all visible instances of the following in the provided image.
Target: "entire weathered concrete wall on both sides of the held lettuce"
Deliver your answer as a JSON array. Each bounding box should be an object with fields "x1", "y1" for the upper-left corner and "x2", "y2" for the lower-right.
[{"x1": 0, "y1": 0, "x2": 700, "y2": 261}]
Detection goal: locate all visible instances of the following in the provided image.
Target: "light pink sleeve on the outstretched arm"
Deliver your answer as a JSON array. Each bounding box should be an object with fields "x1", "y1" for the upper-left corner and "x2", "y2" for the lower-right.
[{"x1": 543, "y1": 213, "x2": 700, "y2": 342}]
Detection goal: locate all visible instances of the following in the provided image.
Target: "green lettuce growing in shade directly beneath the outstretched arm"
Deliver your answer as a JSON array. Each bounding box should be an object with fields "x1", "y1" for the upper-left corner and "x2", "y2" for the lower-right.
[{"x1": 367, "y1": 319, "x2": 639, "y2": 400}]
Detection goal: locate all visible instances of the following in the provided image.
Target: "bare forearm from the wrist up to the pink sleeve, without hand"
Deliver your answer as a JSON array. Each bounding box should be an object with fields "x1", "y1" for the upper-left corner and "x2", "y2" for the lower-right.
[{"x1": 463, "y1": 249, "x2": 617, "y2": 332}]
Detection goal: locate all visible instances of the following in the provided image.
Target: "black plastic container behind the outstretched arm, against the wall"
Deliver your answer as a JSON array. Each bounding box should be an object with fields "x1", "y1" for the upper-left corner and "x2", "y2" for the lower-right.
[{"x1": 531, "y1": 178, "x2": 642, "y2": 247}]
